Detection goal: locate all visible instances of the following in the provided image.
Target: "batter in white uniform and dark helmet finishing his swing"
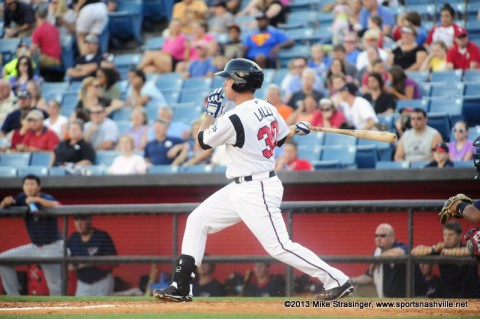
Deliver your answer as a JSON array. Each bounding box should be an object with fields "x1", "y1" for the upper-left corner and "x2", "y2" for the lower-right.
[{"x1": 153, "y1": 59, "x2": 353, "y2": 301}]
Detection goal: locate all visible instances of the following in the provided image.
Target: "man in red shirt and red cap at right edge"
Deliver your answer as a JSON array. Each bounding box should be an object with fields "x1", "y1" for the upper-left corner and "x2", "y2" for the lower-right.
[{"x1": 447, "y1": 26, "x2": 480, "y2": 70}]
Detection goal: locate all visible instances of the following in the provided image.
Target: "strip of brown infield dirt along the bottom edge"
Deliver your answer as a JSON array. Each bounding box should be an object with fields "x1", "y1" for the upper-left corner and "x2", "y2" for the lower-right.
[{"x1": 0, "y1": 299, "x2": 480, "y2": 317}]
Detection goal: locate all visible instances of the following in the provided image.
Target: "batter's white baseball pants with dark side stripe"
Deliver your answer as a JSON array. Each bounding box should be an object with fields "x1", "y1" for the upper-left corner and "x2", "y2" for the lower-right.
[{"x1": 182, "y1": 176, "x2": 348, "y2": 289}]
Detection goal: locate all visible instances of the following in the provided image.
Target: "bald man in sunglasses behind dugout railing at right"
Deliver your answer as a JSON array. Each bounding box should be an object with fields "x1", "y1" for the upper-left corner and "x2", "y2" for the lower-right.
[{"x1": 350, "y1": 223, "x2": 423, "y2": 298}]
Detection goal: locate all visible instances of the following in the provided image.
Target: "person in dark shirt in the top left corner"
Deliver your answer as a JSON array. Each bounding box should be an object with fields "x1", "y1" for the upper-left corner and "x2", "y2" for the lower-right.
[{"x1": 3, "y1": 0, "x2": 35, "y2": 38}]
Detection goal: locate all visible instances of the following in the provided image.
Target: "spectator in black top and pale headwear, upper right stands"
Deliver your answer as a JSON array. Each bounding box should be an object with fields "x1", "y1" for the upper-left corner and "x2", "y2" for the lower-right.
[{"x1": 388, "y1": 23, "x2": 427, "y2": 71}]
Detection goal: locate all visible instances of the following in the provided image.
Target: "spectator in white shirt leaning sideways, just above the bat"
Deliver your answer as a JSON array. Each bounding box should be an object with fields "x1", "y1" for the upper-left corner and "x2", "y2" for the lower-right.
[{"x1": 340, "y1": 83, "x2": 378, "y2": 130}]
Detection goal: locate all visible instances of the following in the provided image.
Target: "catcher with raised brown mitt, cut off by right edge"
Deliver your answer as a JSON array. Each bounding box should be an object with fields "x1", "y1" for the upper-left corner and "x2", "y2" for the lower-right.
[{"x1": 439, "y1": 136, "x2": 480, "y2": 261}]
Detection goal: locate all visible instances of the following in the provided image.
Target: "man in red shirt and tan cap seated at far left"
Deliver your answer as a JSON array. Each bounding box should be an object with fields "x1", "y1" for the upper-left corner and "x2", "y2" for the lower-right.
[{"x1": 23, "y1": 110, "x2": 59, "y2": 152}]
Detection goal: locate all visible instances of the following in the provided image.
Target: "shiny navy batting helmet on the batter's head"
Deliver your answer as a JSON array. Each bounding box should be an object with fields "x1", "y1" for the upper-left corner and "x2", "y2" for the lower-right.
[{"x1": 215, "y1": 59, "x2": 263, "y2": 92}]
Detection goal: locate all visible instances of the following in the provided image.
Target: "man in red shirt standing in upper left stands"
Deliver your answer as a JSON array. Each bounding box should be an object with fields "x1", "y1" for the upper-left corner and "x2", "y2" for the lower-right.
[{"x1": 32, "y1": 8, "x2": 62, "y2": 68}]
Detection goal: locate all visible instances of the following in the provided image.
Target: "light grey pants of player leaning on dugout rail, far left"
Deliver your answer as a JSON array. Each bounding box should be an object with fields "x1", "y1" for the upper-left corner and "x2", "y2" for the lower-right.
[{"x1": 0, "y1": 240, "x2": 63, "y2": 296}]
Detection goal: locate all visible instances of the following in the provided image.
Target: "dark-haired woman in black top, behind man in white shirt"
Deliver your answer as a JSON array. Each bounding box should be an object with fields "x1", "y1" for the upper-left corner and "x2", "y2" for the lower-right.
[{"x1": 363, "y1": 72, "x2": 396, "y2": 115}]
